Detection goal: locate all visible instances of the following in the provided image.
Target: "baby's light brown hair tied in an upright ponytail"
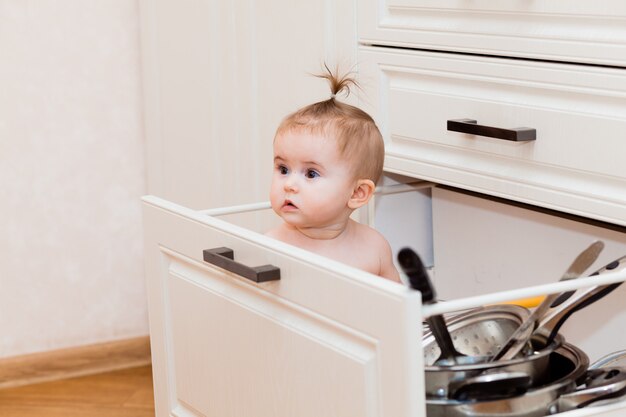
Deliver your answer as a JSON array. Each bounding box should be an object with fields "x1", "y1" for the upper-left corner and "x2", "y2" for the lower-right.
[{"x1": 275, "y1": 65, "x2": 385, "y2": 183}]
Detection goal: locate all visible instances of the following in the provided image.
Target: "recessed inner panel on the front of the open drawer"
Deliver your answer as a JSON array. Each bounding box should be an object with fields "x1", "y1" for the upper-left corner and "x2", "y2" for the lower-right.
[{"x1": 168, "y1": 261, "x2": 372, "y2": 416}]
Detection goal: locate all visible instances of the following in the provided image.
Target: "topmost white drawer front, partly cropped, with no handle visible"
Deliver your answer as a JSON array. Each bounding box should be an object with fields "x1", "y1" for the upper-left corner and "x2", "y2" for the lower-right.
[{"x1": 358, "y1": 0, "x2": 626, "y2": 66}]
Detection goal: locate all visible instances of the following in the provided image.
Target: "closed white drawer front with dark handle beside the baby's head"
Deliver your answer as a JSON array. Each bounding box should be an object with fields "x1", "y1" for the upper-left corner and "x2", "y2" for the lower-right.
[{"x1": 359, "y1": 47, "x2": 626, "y2": 224}]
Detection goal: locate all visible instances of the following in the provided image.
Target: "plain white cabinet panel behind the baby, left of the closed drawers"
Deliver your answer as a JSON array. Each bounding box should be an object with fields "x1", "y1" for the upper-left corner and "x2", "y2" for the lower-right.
[{"x1": 140, "y1": 0, "x2": 357, "y2": 209}]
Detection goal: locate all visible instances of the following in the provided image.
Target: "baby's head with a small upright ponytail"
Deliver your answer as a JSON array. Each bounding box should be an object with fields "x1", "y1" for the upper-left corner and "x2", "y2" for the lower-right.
[{"x1": 270, "y1": 66, "x2": 385, "y2": 230}]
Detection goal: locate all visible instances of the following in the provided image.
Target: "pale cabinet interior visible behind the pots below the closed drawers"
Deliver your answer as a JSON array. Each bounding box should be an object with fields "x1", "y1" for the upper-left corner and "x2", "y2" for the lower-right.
[{"x1": 426, "y1": 186, "x2": 626, "y2": 360}]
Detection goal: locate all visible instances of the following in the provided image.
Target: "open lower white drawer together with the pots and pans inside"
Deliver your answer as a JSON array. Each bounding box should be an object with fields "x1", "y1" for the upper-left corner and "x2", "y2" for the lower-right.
[{"x1": 143, "y1": 196, "x2": 626, "y2": 417}]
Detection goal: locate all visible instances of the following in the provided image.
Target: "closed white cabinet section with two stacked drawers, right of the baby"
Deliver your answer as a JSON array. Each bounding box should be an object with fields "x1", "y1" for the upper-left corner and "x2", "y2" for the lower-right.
[{"x1": 358, "y1": 0, "x2": 626, "y2": 225}]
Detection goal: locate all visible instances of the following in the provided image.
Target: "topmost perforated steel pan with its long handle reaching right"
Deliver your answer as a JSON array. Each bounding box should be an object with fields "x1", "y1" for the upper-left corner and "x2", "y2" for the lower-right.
[{"x1": 416, "y1": 252, "x2": 626, "y2": 399}]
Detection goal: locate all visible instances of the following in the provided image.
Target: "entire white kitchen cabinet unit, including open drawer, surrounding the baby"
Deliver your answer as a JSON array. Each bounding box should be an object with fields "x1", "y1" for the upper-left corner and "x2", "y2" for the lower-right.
[{"x1": 142, "y1": 0, "x2": 626, "y2": 417}]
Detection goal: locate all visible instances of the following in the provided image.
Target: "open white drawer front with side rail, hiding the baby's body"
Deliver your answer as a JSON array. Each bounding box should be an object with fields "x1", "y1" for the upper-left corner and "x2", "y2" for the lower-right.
[{"x1": 144, "y1": 196, "x2": 626, "y2": 417}]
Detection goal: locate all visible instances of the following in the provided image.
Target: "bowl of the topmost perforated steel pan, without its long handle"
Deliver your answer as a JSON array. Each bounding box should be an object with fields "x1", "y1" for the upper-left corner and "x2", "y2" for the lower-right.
[{"x1": 423, "y1": 305, "x2": 563, "y2": 398}]
